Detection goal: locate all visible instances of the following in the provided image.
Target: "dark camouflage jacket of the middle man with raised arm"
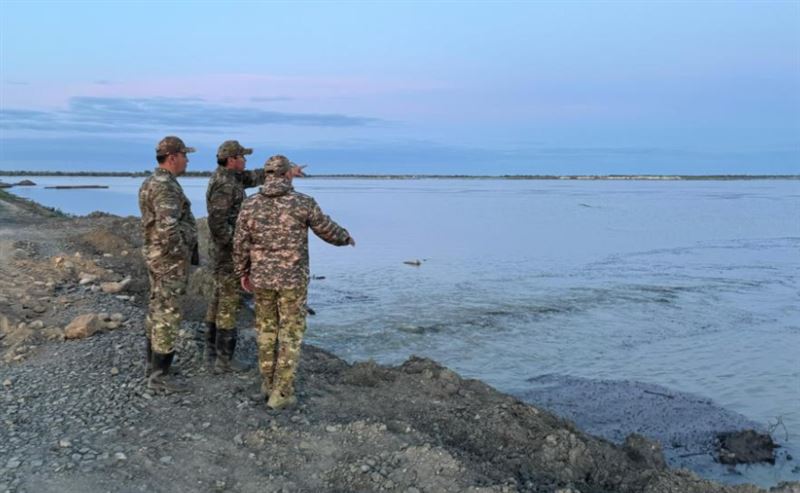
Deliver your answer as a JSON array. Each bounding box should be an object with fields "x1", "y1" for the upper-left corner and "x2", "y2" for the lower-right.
[{"x1": 206, "y1": 166, "x2": 265, "y2": 264}]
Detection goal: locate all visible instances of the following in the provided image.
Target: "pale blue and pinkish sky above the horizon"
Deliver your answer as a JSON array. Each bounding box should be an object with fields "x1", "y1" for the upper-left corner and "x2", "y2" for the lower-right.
[{"x1": 0, "y1": 0, "x2": 800, "y2": 175}]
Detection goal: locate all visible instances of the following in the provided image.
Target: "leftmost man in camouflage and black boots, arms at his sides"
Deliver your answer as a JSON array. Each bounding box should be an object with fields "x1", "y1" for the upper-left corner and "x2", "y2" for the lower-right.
[{"x1": 139, "y1": 136, "x2": 199, "y2": 391}]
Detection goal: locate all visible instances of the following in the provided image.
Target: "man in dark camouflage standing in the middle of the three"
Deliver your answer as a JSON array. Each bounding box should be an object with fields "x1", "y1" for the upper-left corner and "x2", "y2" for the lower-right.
[{"x1": 206, "y1": 140, "x2": 303, "y2": 371}]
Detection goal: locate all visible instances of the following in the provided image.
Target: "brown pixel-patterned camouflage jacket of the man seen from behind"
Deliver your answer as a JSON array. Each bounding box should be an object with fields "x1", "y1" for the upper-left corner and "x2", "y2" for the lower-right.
[{"x1": 233, "y1": 178, "x2": 350, "y2": 289}]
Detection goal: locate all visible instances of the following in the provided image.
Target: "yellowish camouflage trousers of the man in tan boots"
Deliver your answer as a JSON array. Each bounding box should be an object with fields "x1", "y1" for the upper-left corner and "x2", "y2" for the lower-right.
[{"x1": 255, "y1": 287, "x2": 308, "y2": 396}]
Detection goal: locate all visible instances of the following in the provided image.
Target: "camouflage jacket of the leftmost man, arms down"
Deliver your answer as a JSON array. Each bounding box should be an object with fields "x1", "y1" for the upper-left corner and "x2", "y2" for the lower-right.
[{"x1": 139, "y1": 168, "x2": 197, "y2": 276}]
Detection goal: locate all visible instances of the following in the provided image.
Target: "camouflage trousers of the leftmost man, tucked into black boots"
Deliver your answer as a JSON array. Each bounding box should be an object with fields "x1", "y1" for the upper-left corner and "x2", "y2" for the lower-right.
[{"x1": 144, "y1": 269, "x2": 187, "y2": 354}]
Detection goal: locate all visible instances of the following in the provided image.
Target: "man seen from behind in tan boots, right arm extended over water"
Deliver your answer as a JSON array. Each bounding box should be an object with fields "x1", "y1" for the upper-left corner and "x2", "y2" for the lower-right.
[{"x1": 233, "y1": 155, "x2": 356, "y2": 409}]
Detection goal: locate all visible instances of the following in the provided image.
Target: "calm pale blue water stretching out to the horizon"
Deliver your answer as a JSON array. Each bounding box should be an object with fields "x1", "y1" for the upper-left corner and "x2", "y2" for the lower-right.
[{"x1": 6, "y1": 177, "x2": 800, "y2": 485}]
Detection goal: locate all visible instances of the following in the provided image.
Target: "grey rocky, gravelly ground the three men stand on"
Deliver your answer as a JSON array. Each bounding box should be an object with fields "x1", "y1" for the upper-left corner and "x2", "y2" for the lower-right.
[{"x1": 0, "y1": 191, "x2": 800, "y2": 493}]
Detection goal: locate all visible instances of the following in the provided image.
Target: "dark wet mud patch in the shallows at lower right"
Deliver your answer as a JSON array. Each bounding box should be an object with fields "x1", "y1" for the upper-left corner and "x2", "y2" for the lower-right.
[{"x1": 515, "y1": 375, "x2": 800, "y2": 475}]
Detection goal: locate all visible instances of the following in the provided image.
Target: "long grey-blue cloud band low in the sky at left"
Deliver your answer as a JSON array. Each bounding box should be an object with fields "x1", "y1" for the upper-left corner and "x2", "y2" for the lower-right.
[{"x1": 0, "y1": 97, "x2": 381, "y2": 133}]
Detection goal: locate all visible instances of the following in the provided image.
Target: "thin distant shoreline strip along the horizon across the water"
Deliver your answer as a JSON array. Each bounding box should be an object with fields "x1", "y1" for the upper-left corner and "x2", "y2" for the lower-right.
[{"x1": 0, "y1": 170, "x2": 800, "y2": 181}]
